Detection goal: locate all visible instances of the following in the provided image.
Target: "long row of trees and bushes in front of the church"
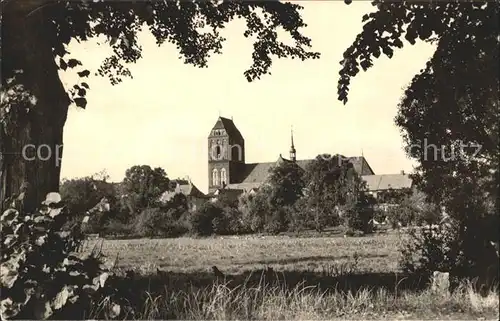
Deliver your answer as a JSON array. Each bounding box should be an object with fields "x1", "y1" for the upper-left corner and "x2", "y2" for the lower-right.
[{"x1": 61, "y1": 155, "x2": 438, "y2": 237}]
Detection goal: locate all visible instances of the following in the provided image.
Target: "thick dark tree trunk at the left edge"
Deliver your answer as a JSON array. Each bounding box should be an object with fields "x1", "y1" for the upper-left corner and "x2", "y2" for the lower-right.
[{"x1": 0, "y1": 0, "x2": 70, "y2": 211}]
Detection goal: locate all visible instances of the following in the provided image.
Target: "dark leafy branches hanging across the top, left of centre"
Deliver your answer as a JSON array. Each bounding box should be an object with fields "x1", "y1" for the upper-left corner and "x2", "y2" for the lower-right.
[{"x1": 46, "y1": 1, "x2": 319, "y2": 88}]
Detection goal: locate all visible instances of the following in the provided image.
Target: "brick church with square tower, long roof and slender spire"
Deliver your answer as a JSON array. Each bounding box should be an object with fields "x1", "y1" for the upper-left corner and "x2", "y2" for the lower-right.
[{"x1": 208, "y1": 117, "x2": 412, "y2": 196}]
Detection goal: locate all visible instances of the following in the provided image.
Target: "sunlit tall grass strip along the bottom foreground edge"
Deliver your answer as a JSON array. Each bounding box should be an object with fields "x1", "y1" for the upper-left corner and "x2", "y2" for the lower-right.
[{"x1": 91, "y1": 283, "x2": 499, "y2": 320}]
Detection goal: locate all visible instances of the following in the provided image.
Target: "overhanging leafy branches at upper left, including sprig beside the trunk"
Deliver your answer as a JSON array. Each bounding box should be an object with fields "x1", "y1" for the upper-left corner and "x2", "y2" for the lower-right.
[{"x1": 2, "y1": 0, "x2": 319, "y2": 107}]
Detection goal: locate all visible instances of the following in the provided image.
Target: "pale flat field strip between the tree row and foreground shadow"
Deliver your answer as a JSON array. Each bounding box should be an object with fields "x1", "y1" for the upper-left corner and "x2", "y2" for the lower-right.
[{"x1": 86, "y1": 232, "x2": 403, "y2": 273}]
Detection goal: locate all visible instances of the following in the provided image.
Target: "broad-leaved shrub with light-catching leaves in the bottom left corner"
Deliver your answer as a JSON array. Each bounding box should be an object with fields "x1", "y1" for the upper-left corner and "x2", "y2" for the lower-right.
[{"x1": 0, "y1": 193, "x2": 117, "y2": 320}]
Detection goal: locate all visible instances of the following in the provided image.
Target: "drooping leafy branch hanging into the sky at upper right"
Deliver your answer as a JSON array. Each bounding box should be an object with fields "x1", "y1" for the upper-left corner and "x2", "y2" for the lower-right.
[{"x1": 338, "y1": 0, "x2": 488, "y2": 104}]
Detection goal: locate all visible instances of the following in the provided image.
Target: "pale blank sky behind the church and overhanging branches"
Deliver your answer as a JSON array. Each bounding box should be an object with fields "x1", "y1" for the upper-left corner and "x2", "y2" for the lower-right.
[{"x1": 57, "y1": 1, "x2": 434, "y2": 192}]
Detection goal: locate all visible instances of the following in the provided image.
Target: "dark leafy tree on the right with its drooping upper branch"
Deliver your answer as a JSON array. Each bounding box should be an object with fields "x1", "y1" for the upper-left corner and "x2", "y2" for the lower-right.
[{"x1": 338, "y1": 0, "x2": 500, "y2": 275}]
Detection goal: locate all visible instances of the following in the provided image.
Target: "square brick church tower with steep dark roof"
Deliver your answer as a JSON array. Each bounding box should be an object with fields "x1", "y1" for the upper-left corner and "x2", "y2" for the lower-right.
[{"x1": 208, "y1": 117, "x2": 245, "y2": 193}]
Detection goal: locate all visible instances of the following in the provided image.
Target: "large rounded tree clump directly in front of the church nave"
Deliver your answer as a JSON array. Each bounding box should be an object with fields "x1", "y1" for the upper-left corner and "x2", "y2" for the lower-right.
[{"x1": 236, "y1": 155, "x2": 374, "y2": 232}]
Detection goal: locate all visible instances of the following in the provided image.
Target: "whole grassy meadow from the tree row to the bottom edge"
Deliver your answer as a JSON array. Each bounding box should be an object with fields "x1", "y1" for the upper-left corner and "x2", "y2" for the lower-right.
[{"x1": 87, "y1": 231, "x2": 499, "y2": 320}]
